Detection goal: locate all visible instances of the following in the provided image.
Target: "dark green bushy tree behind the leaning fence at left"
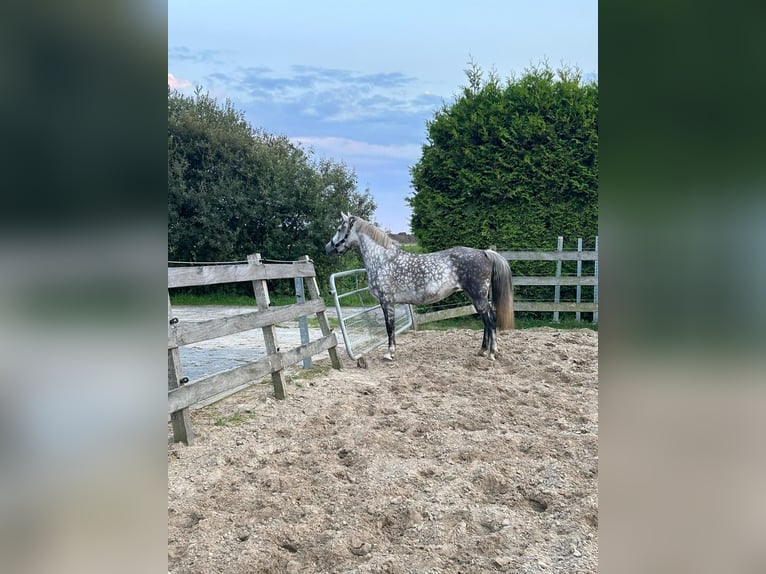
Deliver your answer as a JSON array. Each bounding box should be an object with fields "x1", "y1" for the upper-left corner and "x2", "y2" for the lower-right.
[{"x1": 168, "y1": 89, "x2": 376, "y2": 292}]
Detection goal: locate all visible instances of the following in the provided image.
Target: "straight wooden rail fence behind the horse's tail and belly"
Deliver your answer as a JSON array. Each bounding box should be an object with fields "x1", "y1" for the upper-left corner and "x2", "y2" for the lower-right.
[{"x1": 413, "y1": 237, "x2": 598, "y2": 328}]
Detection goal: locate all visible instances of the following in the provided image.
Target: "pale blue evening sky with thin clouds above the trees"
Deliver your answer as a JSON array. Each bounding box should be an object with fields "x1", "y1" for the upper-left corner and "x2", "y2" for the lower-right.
[{"x1": 168, "y1": 0, "x2": 598, "y2": 232}]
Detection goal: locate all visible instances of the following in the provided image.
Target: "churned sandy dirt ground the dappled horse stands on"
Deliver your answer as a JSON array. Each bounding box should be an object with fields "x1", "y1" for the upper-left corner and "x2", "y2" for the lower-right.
[{"x1": 168, "y1": 328, "x2": 598, "y2": 574}]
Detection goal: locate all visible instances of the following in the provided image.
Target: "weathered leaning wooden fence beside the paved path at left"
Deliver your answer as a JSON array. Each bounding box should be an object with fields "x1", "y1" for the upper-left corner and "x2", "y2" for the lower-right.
[{"x1": 168, "y1": 254, "x2": 341, "y2": 445}]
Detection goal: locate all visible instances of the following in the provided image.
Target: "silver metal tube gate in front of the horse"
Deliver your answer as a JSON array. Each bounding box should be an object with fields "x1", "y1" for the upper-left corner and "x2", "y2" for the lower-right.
[{"x1": 330, "y1": 269, "x2": 413, "y2": 360}]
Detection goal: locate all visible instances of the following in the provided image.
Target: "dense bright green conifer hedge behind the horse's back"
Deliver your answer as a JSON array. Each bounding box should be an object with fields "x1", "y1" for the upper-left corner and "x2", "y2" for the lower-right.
[{"x1": 407, "y1": 63, "x2": 598, "y2": 250}]
